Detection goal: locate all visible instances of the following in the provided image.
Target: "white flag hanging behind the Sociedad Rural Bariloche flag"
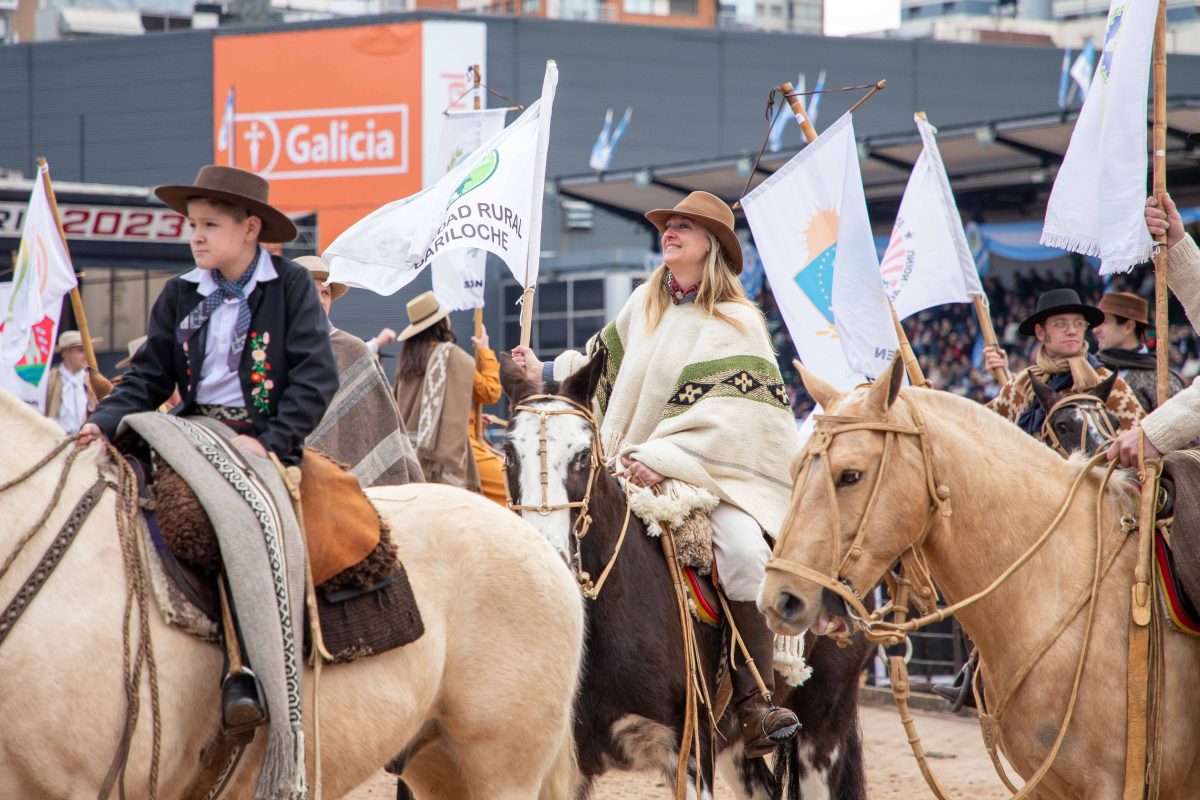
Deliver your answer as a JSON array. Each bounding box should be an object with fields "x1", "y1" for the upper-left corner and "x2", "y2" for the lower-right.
[{"x1": 432, "y1": 108, "x2": 508, "y2": 311}]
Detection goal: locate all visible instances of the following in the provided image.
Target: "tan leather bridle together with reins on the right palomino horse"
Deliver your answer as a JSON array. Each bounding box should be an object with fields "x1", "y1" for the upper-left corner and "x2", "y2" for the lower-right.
[{"x1": 767, "y1": 393, "x2": 1140, "y2": 800}]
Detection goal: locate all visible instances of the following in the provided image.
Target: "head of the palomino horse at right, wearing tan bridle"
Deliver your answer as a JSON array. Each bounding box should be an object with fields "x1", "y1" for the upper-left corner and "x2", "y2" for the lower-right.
[{"x1": 758, "y1": 359, "x2": 940, "y2": 634}]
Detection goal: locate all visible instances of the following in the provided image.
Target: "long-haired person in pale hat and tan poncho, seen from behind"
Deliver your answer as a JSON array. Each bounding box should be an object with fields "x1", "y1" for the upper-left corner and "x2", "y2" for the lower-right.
[{"x1": 396, "y1": 291, "x2": 481, "y2": 492}]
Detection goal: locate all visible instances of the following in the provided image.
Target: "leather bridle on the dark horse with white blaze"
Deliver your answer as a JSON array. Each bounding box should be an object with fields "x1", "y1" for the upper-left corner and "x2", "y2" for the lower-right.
[{"x1": 504, "y1": 395, "x2": 632, "y2": 600}]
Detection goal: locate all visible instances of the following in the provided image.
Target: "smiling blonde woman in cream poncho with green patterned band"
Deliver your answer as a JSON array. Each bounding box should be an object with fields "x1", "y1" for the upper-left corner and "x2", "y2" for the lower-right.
[{"x1": 512, "y1": 192, "x2": 800, "y2": 756}]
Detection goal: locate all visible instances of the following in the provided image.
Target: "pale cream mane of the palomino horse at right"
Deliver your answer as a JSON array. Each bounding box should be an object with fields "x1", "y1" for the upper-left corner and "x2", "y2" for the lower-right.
[{"x1": 901, "y1": 387, "x2": 1138, "y2": 512}]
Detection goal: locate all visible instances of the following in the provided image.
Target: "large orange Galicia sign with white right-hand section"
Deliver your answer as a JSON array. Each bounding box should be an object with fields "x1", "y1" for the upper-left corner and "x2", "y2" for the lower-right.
[{"x1": 212, "y1": 22, "x2": 486, "y2": 247}]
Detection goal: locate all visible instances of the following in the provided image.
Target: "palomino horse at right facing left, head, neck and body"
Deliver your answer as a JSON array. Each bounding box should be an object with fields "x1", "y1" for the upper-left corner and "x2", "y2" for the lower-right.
[{"x1": 758, "y1": 362, "x2": 1200, "y2": 800}]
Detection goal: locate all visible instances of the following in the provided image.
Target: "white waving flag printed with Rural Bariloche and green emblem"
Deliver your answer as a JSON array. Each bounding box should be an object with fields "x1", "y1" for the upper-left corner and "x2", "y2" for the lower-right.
[{"x1": 324, "y1": 61, "x2": 558, "y2": 295}]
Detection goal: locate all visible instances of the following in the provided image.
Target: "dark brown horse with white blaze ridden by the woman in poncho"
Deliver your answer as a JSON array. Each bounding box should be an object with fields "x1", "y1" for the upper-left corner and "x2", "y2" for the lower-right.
[{"x1": 500, "y1": 353, "x2": 869, "y2": 800}]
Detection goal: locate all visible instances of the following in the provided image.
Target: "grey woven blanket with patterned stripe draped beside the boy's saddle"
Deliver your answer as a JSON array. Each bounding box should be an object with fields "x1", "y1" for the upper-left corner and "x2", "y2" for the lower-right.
[{"x1": 121, "y1": 413, "x2": 307, "y2": 800}]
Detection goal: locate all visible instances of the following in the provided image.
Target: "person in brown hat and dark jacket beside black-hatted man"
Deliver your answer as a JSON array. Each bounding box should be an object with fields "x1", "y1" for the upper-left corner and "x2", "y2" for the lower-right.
[{"x1": 1092, "y1": 291, "x2": 1183, "y2": 414}]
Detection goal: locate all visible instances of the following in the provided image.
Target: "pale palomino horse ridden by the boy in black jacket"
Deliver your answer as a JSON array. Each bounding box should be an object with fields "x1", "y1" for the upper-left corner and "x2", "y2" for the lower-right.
[{"x1": 0, "y1": 391, "x2": 583, "y2": 800}]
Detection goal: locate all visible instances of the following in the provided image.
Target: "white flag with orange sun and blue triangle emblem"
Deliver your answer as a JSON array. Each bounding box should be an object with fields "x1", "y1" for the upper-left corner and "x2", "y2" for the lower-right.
[{"x1": 742, "y1": 114, "x2": 896, "y2": 390}]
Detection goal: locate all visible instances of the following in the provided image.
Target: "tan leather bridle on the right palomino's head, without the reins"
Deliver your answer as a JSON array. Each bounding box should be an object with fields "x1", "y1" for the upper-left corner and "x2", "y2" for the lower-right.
[{"x1": 767, "y1": 395, "x2": 950, "y2": 645}]
